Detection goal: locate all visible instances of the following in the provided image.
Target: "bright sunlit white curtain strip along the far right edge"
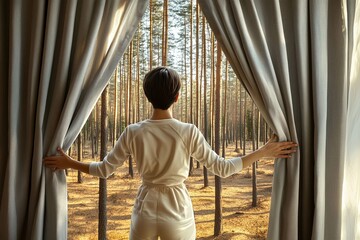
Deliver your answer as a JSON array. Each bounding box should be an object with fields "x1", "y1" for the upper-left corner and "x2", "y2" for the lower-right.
[{"x1": 341, "y1": 4, "x2": 360, "y2": 239}]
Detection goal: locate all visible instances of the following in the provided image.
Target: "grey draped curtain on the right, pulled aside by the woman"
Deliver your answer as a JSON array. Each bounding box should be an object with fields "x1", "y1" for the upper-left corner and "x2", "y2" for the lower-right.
[{"x1": 199, "y1": 0, "x2": 360, "y2": 239}]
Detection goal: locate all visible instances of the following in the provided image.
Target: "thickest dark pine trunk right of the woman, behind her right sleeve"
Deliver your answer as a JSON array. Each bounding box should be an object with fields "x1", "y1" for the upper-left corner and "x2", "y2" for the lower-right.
[{"x1": 214, "y1": 42, "x2": 222, "y2": 236}]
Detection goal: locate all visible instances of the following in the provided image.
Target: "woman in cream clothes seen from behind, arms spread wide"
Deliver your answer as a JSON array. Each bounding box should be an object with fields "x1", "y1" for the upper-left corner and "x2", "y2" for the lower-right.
[{"x1": 44, "y1": 67, "x2": 297, "y2": 240}]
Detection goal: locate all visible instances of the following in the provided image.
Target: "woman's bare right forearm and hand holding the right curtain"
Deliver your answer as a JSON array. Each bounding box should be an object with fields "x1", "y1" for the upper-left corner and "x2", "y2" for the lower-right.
[{"x1": 242, "y1": 135, "x2": 298, "y2": 168}]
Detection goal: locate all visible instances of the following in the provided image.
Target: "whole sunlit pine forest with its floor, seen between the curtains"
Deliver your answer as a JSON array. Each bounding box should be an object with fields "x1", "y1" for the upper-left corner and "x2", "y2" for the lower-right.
[{"x1": 67, "y1": 0, "x2": 274, "y2": 239}]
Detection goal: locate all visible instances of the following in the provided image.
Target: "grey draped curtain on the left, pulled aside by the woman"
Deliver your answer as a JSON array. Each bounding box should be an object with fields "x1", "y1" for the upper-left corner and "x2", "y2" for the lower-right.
[{"x1": 0, "y1": 0, "x2": 148, "y2": 239}]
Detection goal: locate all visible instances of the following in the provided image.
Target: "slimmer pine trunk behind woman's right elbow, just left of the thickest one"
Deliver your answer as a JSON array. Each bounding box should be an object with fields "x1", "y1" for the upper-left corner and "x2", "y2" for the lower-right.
[{"x1": 202, "y1": 17, "x2": 209, "y2": 187}]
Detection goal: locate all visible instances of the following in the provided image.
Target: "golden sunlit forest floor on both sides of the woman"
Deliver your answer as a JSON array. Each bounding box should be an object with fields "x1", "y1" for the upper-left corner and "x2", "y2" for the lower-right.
[{"x1": 67, "y1": 145, "x2": 274, "y2": 240}]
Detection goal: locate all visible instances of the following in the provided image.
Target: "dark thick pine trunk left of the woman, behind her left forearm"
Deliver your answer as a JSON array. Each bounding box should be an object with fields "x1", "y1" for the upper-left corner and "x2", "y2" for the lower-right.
[{"x1": 98, "y1": 87, "x2": 108, "y2": 240}]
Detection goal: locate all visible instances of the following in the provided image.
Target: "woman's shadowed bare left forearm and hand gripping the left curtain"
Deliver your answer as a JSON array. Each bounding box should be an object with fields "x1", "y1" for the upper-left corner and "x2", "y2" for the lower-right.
[{"x1": 44, "y1": 147, "x2": 90, "y2": 174}]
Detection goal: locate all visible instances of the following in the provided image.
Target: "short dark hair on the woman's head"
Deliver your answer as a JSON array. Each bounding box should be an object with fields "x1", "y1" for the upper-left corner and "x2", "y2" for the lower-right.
[{"x1": 143, "y1": 67, "x2": 181, "y2": 110}]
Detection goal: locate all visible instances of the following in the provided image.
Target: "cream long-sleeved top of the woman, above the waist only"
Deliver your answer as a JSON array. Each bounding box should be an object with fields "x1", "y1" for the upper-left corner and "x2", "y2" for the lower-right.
[{"x1": 90, "y1": 119, "x2": 242, "y2": 186}]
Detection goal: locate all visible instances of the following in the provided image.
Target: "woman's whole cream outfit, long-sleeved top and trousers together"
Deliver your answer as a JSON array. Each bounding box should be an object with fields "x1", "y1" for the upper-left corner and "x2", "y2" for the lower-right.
[{"x1": 90, "y1": 119, "x2": 242, "y2": 240}]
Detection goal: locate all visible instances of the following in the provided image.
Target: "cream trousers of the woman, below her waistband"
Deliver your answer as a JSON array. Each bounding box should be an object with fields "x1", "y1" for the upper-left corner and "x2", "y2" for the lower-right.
[{"x1": 130, "y1": 184, "x2": 196, "y2": 240}]
